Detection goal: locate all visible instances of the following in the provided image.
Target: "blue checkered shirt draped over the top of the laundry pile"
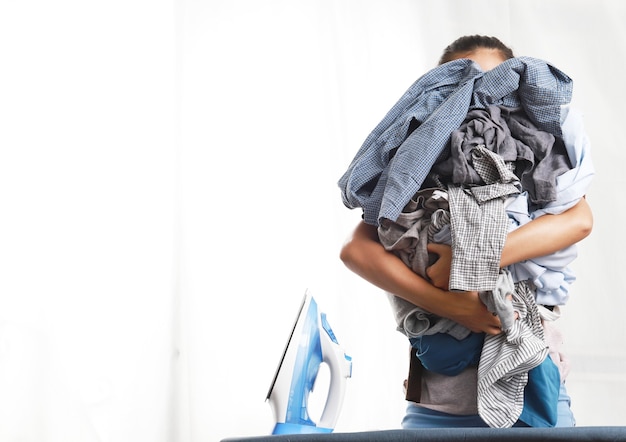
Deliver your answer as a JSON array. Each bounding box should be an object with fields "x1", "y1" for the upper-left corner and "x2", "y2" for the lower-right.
[{"x1": 338, "y1": 57, "x2": 573, "y2": 225}]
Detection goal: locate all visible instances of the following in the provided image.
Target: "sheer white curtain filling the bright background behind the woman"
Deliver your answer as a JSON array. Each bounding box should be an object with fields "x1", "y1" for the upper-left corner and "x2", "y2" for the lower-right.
[{"x1": 0, "y1": 0, "x2": 626, "y2": 442}]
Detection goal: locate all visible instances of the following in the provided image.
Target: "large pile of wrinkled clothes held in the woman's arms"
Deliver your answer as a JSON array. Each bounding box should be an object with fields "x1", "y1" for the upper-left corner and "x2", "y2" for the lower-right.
[{"x1": 339, "y1": 57, "x2": 594, "y2": 427}]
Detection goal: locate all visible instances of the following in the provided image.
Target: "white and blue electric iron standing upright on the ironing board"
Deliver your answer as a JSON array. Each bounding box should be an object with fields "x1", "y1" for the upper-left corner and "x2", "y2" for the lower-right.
[{"x1": 265, "y1": 291, "x2": 352, "y2": 434}]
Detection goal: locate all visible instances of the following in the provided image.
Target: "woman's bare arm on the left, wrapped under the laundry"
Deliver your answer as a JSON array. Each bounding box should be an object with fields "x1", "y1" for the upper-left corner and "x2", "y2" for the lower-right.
[{"x1": 340, "y1": 222, "x2": 501, "y2": 334}]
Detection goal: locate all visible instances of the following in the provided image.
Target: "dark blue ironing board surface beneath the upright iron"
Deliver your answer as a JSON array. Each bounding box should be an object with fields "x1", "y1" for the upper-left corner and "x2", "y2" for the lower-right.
[{"x1": 222, "y1": 426, "x2": 626, "y2": 442}]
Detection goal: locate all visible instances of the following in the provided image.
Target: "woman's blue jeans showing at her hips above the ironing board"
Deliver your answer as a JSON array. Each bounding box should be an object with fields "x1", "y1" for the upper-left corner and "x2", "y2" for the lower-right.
[{"x1": 402, "y1": 384, "x2": 576, "y2": 430}]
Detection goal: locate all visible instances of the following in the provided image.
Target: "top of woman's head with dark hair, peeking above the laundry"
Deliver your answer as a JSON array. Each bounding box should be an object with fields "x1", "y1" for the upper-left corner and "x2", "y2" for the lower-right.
[{"x1": 439, "y1": 35, "x2": 514, "y2": 71}]
